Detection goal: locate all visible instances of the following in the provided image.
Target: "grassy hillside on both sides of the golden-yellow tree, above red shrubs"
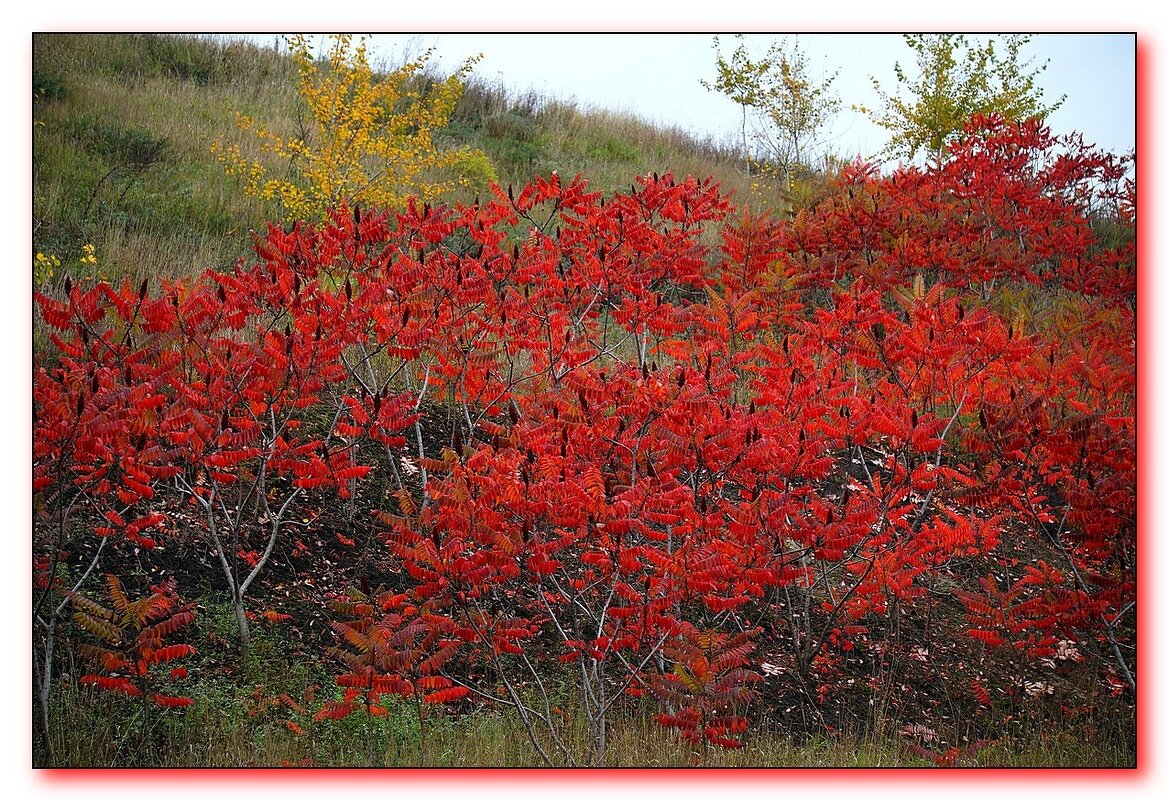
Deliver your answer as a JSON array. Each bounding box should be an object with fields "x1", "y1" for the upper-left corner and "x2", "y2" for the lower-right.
[{"x1": 33, "y1": 34, "x2": 749, "y2": 287}]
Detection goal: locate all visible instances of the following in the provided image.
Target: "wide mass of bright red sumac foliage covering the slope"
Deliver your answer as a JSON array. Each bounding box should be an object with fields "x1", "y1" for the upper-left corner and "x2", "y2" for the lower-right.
[{"x1": 34, "y1": 119, "x2": 1135, "y2": 747}]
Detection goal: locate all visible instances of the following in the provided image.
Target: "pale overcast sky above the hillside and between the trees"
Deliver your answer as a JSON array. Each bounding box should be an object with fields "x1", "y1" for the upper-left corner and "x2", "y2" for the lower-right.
[{"x1": 257, "y1": 34, "x2": 1136, "y2": 164}]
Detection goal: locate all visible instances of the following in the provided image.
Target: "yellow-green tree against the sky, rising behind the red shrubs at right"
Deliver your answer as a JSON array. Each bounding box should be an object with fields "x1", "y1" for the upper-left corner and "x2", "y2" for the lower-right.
[{"x1": 857, "y1": 34, "x2": 1064, "y2": 163}]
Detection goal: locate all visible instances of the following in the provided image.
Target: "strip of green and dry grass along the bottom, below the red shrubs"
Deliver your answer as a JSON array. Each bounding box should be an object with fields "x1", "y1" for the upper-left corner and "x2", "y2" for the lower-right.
[{"x1": 41, "y1": 679, "x2": 1135, "y2": 768}]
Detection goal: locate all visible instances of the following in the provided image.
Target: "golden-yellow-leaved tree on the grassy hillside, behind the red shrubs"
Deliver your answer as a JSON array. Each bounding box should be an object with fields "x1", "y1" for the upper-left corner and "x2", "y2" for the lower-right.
[{"x1": 212, "y1": 34, "x2": 494, "y2": 220}]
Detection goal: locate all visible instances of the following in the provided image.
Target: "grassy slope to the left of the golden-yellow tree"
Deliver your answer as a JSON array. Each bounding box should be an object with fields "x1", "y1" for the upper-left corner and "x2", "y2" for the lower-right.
[{"x1": 33, "y1": 34, "x2": 296, "y2": 284}]
